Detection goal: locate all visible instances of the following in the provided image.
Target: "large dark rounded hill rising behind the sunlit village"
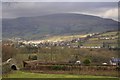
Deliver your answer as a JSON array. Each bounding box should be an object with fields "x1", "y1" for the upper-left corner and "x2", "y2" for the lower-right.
[{"x1": 2, "y1": 13, "x2": 117, "y2": 39}]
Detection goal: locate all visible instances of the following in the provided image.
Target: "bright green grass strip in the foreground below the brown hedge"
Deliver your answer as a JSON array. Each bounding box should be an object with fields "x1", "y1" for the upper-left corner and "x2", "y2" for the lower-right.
[{"x1": 3, "y1": 71, "x2": 116, "y2": 79}]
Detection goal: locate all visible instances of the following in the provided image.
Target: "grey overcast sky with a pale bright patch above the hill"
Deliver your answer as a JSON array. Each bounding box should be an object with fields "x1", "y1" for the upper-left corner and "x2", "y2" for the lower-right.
[{"x1": 0, "y1": 0, "x2": 118, "y2": 20}]
